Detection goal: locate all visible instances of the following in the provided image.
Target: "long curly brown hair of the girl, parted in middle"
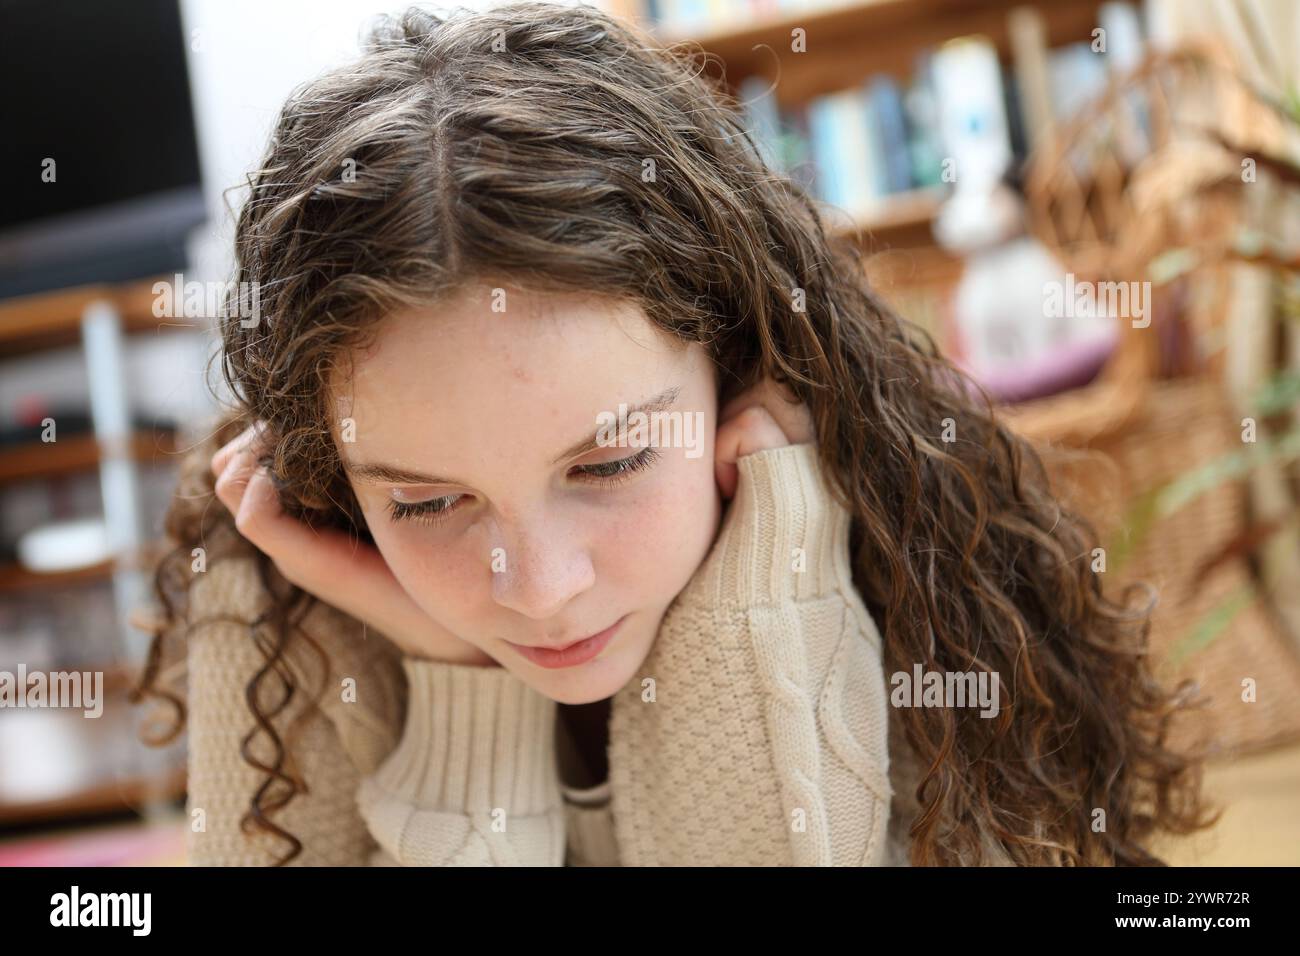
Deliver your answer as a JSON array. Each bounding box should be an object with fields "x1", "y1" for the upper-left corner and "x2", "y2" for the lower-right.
[{"x1": 138, "y1": 3, "x2": 1213, "y2": 865}]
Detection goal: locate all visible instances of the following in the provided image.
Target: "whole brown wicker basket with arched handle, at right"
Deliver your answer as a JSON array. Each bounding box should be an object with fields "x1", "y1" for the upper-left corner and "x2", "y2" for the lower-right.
[{"x1": 1005, "y1": 41, "x2": 1300, "y2": 752}]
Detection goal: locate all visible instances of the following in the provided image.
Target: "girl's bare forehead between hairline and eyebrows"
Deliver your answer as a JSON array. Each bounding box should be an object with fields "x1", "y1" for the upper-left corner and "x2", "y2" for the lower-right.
[{"x1": 333, "y1": 287, "x2": 703, "y2": 471}]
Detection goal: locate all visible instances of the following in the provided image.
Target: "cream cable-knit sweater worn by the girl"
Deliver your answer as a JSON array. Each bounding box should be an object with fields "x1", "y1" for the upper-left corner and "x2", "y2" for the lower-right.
[{"x1": 187, "y1": 445, "x2": 930, "y2": 866}]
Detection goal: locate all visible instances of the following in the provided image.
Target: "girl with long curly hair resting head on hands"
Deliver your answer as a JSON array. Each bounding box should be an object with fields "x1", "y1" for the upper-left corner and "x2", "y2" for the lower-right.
[{"x1": 140, "y1": 3, "x2": 1209, "y2": 865}]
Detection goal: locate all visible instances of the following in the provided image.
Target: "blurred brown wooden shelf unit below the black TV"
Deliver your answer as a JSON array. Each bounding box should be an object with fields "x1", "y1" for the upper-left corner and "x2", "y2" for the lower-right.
[{"x1": 0, "y1": 276, "x2": 192, "y2": 832}]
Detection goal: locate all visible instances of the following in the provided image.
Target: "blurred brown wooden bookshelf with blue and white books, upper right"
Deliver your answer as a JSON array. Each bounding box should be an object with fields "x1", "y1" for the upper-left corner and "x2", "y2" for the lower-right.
[{"x1": 607, "y1": 0, "x2": 1140, "y2": 325}]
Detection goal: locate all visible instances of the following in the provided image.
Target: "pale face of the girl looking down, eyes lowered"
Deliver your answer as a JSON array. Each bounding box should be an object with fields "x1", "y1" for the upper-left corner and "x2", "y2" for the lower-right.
[{"x1": 335, "y1": 287, "x2": 722, "y2": 704}]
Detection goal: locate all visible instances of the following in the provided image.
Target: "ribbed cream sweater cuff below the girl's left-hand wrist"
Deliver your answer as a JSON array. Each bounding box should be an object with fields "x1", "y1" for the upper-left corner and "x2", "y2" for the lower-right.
[{"x1": 358, "y1": 657, "x2": 566, "y2": 866}]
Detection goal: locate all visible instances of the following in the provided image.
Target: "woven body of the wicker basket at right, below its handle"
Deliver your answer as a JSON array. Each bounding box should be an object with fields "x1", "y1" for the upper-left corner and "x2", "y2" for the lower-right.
[{"x1": 1047, "y1": 377, "x2": 1300, "y2": 752}]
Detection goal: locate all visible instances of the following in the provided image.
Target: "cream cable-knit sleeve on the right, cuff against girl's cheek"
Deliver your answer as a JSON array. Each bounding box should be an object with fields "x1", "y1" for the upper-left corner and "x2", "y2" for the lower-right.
[{"x1": 610, "y1": 445, "x2": 892, "y2": 866}]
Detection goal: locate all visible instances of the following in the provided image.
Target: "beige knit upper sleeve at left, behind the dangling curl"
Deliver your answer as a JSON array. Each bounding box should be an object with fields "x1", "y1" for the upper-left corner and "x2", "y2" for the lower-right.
[{"x1": 186, "y1": 558, "x2": 400, "y2": 866}]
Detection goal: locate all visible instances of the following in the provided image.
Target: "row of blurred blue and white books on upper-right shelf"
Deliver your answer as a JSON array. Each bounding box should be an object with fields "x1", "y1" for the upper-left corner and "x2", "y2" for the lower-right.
[{"x1": 712, "y1": 3, "x2": 1143, "y2": 222}]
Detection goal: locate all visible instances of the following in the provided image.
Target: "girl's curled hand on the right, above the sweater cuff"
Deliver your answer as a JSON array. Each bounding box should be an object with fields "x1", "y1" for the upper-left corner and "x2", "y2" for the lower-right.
[{"x1": 714, "y1": 378, "x2": 816, "y2": 498}]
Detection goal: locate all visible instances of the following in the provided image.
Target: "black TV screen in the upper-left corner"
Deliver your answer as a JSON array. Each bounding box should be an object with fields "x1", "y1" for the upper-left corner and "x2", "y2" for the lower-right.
[{"x1": 0, "y1": 0, "x2": 204, "y2": 298}]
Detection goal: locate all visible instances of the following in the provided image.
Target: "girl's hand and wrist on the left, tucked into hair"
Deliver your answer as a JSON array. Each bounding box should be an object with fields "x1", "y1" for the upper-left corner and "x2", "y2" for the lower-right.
[{"x1": 212, "y1": 423, "x2": 497, "y2": 666}]
